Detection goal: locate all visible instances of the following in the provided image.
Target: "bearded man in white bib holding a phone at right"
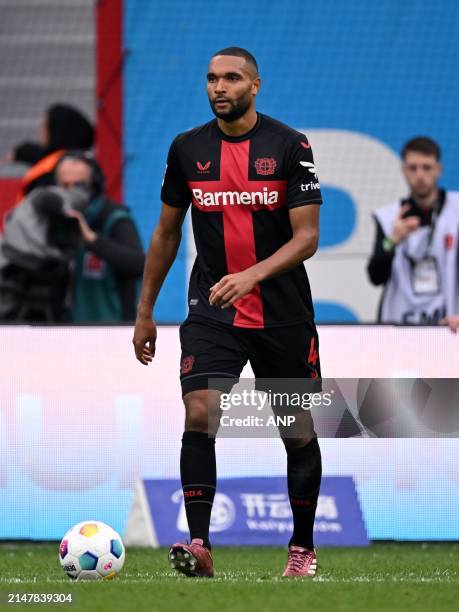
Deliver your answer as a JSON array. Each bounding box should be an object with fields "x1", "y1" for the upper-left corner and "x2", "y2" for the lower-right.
[{"x1": 368, "y1": 136, "x2": 459, "y2": 324}]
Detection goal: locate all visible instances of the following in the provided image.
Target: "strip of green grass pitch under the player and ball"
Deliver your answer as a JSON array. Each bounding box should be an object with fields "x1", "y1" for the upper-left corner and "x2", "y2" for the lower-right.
[{"x1": 0, "y1": 543, "x2": 459, "y2": 612}]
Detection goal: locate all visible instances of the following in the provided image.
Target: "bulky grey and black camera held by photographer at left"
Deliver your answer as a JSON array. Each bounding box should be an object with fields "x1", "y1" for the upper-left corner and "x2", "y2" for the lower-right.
[{"x1": 0, "y1": 180, "x2": 84, "y2": 323}]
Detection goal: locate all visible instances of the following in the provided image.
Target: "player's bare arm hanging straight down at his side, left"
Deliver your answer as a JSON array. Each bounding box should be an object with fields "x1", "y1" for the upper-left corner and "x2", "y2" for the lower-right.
[{"x1": 132, "y1": 204, "x2": 186, "y2": 365}]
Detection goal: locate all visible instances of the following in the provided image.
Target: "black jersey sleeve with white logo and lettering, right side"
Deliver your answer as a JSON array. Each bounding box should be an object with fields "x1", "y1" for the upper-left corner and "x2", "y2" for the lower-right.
[{"x1": 286, "y1": 136, "x2": 322, "y2": 208}]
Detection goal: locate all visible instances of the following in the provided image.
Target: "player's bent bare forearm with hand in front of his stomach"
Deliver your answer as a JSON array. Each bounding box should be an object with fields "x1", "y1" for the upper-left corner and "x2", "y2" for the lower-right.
[{"x1": 209, "y1": 203, "x2": 320, "y2": 308}]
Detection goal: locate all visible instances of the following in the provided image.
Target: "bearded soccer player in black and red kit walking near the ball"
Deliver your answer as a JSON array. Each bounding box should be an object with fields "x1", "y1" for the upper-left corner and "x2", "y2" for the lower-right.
[{"x1": 133, "y1": 47, "x2": 322, "y2": 577}]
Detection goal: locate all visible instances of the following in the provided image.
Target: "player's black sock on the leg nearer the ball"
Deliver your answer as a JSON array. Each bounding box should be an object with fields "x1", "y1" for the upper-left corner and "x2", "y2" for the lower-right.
[{"x1": 180, "y1": 431, "x2": 217, "y2": 548}]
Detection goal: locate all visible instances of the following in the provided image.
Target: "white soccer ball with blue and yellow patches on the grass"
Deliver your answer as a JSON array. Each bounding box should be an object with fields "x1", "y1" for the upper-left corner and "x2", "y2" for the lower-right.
[{"x1": 59, "y1": 521, "x2": 126, "y2": 580}]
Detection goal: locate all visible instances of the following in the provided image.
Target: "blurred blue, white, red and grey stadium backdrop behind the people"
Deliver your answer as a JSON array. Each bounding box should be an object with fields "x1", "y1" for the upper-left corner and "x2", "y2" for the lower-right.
[{"x1": 0, "y1": 0, "x2": 459, "y2": 323}]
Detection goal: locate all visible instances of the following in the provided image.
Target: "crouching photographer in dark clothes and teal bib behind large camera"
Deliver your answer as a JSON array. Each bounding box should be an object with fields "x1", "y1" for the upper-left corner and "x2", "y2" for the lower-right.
[{"x1": 0, "y1": 151, "x2": 144, "y2": 322}]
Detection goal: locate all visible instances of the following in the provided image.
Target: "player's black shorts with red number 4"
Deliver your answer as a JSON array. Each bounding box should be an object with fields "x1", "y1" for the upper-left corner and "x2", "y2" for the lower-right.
[{"x1": 180, "y1": 315, "x2": 321, "y2": 395}]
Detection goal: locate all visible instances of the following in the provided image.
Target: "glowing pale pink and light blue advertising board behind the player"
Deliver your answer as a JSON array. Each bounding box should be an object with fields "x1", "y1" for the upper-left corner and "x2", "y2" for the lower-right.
[{"x1": 0, "y1": 326, "x2": 459, "y2": 539}]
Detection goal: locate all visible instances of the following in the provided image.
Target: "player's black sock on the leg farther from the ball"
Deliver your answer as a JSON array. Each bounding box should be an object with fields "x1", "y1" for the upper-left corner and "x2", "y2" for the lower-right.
[{"x1": 287, "y1": 438, "x2": 322, "y2": 548}]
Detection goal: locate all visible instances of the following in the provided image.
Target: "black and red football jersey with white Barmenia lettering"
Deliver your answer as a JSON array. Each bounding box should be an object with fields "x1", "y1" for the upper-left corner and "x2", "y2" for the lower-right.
[{"x1": 161, "y1": 113, "x2": 322, "y2": 329}]
